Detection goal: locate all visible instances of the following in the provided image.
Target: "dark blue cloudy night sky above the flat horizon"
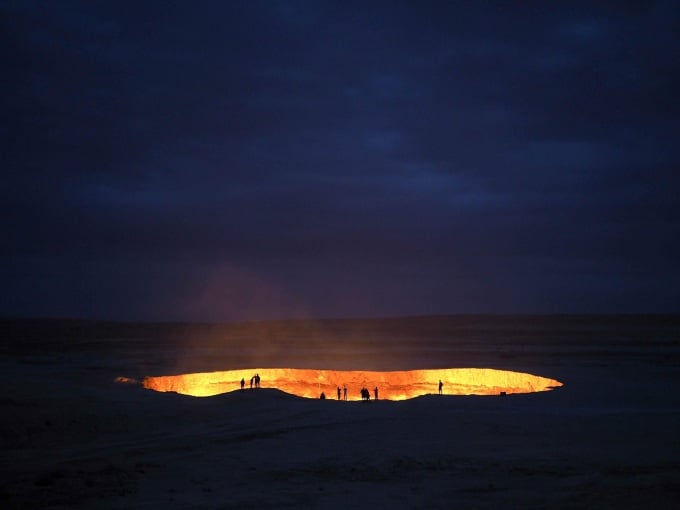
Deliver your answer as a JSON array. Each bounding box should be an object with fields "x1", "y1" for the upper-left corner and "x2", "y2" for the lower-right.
[{"x1": 0, "y1": 0, "x2": 680, "y2": 321}]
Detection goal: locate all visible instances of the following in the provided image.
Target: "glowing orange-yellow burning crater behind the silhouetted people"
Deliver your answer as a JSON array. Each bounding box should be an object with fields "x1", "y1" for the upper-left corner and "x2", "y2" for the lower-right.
[{"x1": 142, "y1": 368, "x2": 562, "y2": 400}]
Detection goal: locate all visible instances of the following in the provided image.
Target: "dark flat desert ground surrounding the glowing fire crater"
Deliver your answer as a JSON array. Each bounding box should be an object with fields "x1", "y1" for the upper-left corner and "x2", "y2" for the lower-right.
[{"x1": 0, "y1": 316, "x2": 680, "y2": 509}]
